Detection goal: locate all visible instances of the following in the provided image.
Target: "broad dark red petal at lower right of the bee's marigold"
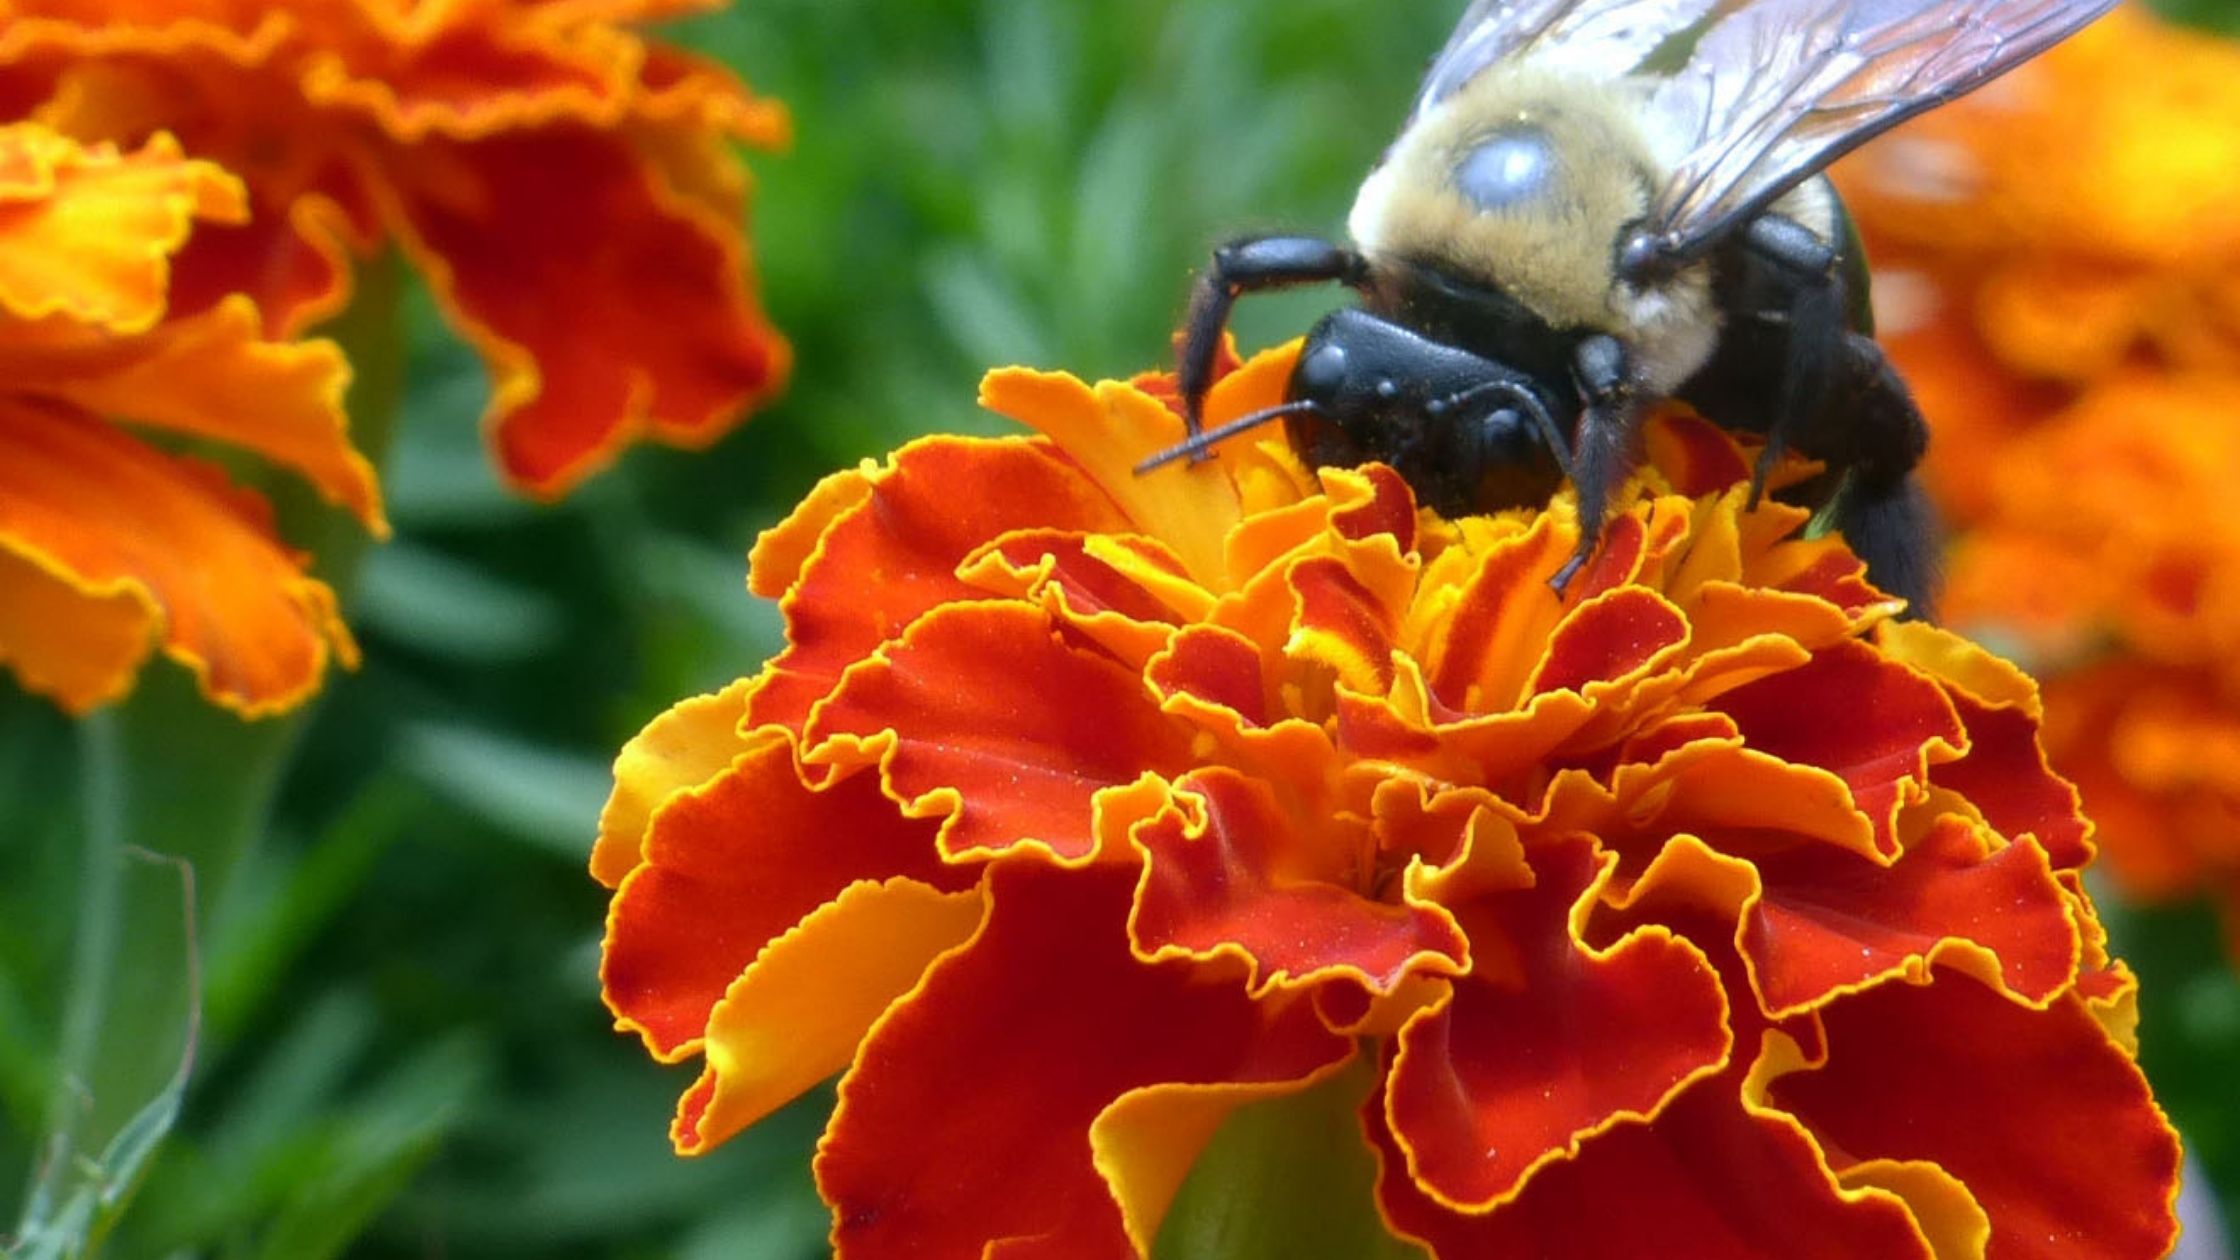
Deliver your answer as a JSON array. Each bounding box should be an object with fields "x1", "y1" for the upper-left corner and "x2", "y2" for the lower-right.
[{"x1": 1772, "y1": 971, "x2": 2177, "y2": 1260}]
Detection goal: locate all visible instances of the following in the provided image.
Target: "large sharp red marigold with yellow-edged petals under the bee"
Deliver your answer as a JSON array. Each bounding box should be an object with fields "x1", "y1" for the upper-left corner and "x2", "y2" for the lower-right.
[{"x1": 591, "y1": 345, "x2": 2177, "y2": 1260}]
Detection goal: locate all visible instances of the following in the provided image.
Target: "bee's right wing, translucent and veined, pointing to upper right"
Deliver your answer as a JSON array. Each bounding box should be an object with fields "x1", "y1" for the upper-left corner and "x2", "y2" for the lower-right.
[{"x1": 1649, "y1": 0, "x2": 2115, "y2": 258}]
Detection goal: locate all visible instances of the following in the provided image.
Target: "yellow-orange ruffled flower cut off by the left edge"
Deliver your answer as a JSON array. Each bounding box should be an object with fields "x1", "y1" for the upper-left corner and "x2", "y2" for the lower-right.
[{"x1": 0, "y1": 123, "x2": 388, "y2": 717}]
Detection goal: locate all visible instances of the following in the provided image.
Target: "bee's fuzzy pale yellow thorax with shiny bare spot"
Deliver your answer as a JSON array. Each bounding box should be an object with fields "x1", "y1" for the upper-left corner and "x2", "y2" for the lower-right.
[{"x1": 1348, "y1": 72, "x2": 1651, "y2": 327}]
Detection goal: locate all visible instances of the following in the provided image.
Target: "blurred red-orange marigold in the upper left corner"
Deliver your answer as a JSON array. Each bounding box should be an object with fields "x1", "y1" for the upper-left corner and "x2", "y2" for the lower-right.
[{"x1": 0, "y1": 0, "x2": 788, "y2": 495}]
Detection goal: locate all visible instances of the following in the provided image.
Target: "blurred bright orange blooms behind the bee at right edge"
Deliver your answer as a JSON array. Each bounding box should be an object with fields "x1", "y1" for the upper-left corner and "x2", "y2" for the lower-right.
[{"x1": 1837, "y1": 9, "x2": 2240, "y2": 957}]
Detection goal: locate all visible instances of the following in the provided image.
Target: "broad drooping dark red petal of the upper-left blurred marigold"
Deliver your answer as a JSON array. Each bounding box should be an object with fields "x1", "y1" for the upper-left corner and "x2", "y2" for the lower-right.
[{"x1": 390, "y1": 128, "x2": 791, "y2": 498}]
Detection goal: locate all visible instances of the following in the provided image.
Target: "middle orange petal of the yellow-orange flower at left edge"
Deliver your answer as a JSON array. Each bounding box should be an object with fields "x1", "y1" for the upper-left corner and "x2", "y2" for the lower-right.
[{"x1": 0, "y1": 296, "x2": 388, "y2": 526}]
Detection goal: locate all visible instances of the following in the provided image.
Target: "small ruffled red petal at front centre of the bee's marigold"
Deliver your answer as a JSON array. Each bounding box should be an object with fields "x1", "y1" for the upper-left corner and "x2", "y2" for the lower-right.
[{"x1": 1129, "y1": 767, "x2": 1469, "y2": 993}]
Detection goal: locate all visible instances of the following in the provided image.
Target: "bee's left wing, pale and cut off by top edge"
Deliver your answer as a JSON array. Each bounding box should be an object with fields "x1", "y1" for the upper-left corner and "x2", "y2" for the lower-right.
[{"x1": 1411, "y1": 0, "x2": 1732, "y2": 117}]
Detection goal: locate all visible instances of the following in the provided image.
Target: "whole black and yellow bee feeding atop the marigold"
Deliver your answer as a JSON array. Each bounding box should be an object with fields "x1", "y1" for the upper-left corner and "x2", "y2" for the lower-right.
[{"x1": 1138, "y1": 0, "x2": 2112, "y2": 617}]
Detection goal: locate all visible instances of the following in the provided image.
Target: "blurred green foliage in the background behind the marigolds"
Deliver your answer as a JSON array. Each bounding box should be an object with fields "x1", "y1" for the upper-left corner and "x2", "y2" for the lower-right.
[{"x1": 0, "y1": 0, "x2": 2240, "y2": 1260}]
